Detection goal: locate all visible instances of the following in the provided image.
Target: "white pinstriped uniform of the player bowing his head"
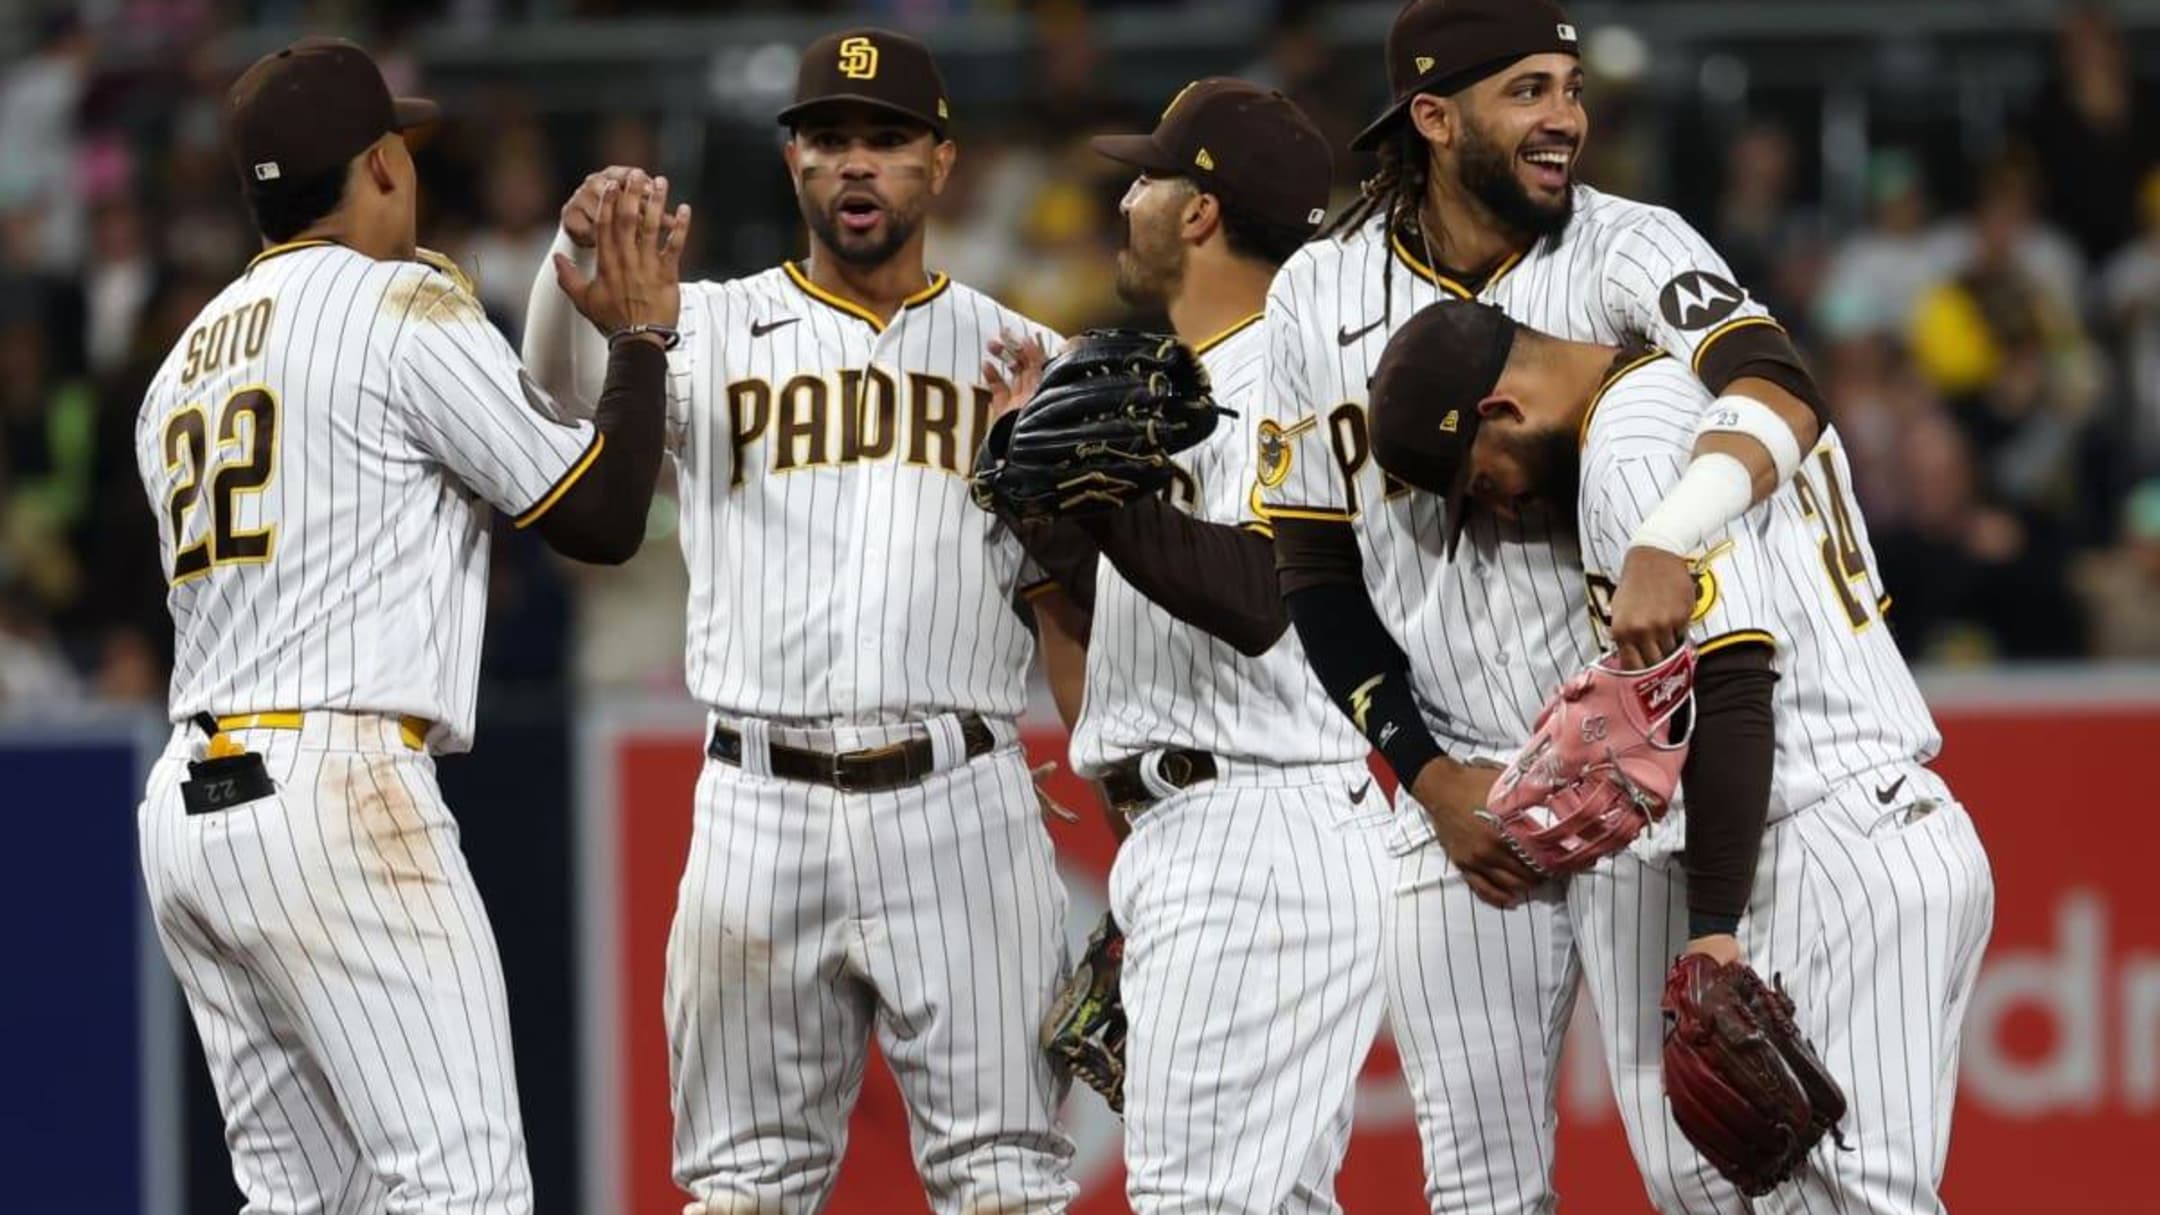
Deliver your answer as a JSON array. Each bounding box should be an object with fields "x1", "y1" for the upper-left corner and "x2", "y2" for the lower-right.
[{"x1": 1568, "y1": 359, "x2": 1994, "y2": 1215}]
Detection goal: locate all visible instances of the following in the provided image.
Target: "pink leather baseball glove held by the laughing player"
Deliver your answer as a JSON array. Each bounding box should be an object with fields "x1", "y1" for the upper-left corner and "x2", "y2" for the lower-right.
[{"x1": 1477, "y1": 644, "x2": 1696, "y2": 878}]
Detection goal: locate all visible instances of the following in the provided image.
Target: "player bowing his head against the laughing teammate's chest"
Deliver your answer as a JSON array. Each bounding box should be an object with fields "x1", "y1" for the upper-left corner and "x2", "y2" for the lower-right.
[{"x1": 1372, "y1": 301, "x2": 1994, "y2": 1215}]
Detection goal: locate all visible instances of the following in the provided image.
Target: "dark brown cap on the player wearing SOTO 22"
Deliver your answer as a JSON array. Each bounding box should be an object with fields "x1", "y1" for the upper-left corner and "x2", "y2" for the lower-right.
[{"x1": 225, "y1": 37, "x2": 441, "y2": 188}]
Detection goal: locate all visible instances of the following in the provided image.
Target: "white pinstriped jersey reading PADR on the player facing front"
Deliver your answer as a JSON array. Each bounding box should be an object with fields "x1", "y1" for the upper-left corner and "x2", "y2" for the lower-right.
[{"x1": 667, "y1": 264, "x2": 1058, "y2": 724}]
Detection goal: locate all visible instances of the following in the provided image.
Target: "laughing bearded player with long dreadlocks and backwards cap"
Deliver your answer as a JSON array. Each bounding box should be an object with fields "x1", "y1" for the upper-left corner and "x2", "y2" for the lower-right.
[{"x1": 1259, "y1": 0, "x2": 1848, "y2": 1213}]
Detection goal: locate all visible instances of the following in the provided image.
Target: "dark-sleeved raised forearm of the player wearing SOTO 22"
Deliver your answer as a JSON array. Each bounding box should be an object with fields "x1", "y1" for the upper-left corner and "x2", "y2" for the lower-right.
[{"x1": 538, "y1": 337, "x2": 667, "y2": 564}]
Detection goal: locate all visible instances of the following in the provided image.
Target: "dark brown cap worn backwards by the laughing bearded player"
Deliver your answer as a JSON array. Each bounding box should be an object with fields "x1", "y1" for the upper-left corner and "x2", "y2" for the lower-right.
[{"x1": 1350, "y1": 0, "x2": 1577, "y2": 151}]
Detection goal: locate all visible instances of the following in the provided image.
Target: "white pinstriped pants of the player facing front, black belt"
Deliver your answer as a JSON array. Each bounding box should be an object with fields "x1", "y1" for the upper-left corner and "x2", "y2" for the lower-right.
[{"x1": 667, "y1": 722, "x2": 1074, "y2": 1215}]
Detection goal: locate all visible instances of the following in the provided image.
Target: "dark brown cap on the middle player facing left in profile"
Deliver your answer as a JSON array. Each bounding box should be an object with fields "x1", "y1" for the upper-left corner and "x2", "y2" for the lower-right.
[{"x1": 1093, "y1": 76, "x2": 1335, "y2": 229}]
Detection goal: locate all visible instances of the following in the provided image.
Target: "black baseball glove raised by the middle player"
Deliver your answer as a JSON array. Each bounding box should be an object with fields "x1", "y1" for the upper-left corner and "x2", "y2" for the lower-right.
[{"x1": 972, "y1": 329, "x2": 1229, "y2": 519}]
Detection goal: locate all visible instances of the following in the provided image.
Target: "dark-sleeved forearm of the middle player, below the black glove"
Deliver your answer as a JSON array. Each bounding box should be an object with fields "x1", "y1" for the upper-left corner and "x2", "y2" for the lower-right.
[{"x1": 1080, "y1": 497, "x2": 1290, "y2": 657}]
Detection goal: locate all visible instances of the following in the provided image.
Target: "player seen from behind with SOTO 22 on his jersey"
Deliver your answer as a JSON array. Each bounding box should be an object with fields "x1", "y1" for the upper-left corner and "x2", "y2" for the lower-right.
[{"x1": 136, "y1": 39, "x2": 689, "y2": 1215}]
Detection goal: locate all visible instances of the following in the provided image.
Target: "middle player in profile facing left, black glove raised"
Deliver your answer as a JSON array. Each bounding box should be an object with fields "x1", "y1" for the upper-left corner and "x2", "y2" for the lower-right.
[{"x1": 993, "y1": 78, "x2": 1389, "y2": 1215}]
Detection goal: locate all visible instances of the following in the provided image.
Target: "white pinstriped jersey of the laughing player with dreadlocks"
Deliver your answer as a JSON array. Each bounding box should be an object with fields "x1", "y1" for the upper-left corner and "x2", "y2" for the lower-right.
[{"x1": 1259, "y1": 186, "x2": 1776, "y2": 755}]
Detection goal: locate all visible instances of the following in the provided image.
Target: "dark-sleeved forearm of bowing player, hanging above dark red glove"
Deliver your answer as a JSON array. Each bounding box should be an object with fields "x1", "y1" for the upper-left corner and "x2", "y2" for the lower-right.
[{"x1": 1680, "y1": 644, "x2": 1778, "y2": 938}]
